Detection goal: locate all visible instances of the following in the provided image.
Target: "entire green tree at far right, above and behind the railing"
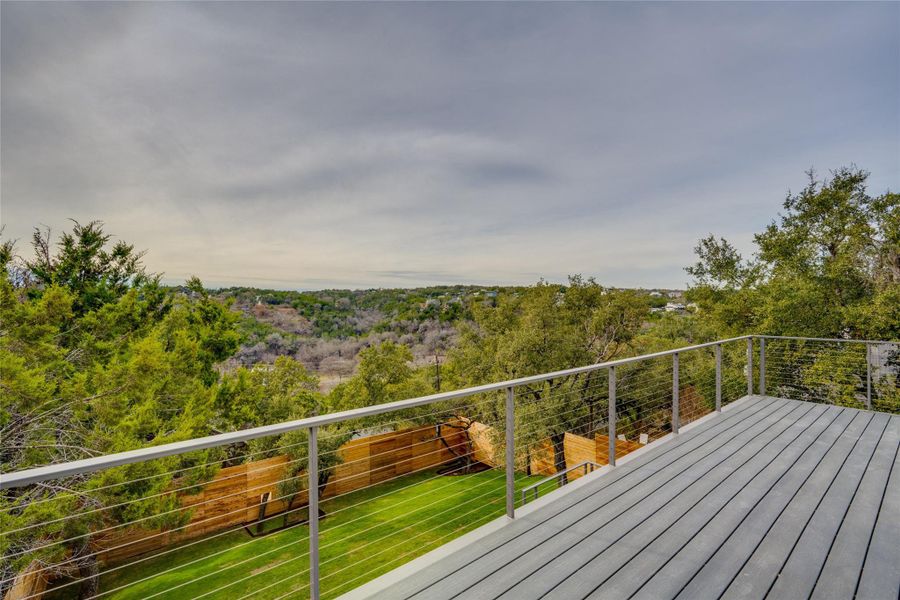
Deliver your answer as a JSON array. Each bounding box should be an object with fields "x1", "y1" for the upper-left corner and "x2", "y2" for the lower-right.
[{"x1": 687, "y1": 168, "x2": 900, "y2": 418}]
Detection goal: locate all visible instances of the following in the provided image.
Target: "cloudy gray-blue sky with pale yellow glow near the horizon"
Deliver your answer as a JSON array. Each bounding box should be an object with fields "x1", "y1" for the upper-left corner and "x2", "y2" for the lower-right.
[{"x1": 0, "y1": 2, "x2": 900, "y2": 289}]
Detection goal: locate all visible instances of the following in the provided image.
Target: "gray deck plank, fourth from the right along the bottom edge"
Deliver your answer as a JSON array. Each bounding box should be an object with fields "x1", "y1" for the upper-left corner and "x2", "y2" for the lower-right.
[{"x1": 722, "y1": 412, "x2": 874, "y2": 599}]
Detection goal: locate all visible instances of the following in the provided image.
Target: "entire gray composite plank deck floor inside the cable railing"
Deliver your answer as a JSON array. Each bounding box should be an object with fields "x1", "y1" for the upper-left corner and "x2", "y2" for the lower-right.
[{"x1": 375, "y1": 396, "x2": 900, "y2": 600}]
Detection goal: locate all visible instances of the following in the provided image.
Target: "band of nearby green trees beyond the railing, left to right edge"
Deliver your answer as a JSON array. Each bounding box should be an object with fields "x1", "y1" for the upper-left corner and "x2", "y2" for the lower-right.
[{"x1": 0, "y1": 168, "x2": 900, "y2": 597}]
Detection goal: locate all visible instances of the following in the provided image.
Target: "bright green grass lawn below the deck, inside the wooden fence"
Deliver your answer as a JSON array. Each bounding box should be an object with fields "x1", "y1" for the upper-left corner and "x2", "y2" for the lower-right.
[{"x1": 50, "y1": 470, "x2": 553, "y2": 599}]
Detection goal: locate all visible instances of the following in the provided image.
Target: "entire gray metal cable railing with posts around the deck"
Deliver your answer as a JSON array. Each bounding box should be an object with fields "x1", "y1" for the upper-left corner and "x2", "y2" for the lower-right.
[{"x1": 0, "y1": 336, "x2": 900, "y2": 600}]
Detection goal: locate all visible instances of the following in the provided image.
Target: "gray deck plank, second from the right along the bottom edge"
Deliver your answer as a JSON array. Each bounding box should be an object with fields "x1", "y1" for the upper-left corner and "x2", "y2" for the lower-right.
[{"x1": 812, "y1": 417, "x2": 900, "y2": 600}]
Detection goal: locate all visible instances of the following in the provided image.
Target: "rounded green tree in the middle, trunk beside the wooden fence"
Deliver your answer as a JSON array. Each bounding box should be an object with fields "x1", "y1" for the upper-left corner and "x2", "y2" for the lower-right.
[{"x1": 447, "y1": 276, "x2": 649, "y2": 482}]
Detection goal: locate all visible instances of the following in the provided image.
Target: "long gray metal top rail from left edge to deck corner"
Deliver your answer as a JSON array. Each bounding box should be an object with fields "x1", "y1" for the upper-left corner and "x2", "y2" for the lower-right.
[{"x1": 0, "y1": 335, "x2": 760, "y2": 490}]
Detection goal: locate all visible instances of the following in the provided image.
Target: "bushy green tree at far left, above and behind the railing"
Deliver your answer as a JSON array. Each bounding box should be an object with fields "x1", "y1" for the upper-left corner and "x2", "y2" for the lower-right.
[{"x1": 0, "y1": 222, "x2": 238, "y2": 597}]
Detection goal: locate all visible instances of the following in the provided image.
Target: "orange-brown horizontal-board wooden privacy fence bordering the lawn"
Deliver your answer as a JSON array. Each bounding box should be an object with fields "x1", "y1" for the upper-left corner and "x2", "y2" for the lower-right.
[{"x1": 93, "y1": 419, "x2": 641, "y2": 563}]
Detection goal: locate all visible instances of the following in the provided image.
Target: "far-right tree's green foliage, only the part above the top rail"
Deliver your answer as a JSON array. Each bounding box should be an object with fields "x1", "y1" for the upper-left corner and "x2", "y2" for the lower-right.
[{"x1": 687, "y1": 168, "x2": 900, "y2": 339}]
